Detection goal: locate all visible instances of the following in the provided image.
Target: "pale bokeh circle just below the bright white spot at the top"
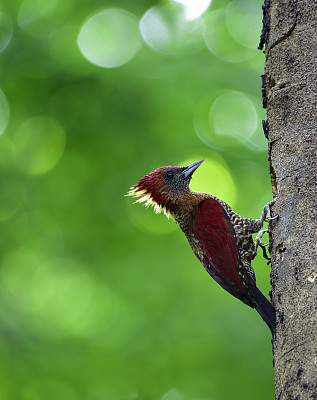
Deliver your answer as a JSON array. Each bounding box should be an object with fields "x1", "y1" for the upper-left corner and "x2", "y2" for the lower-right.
[{"x1": 140, "y1": 3, "x2": 203, "y2": 55}]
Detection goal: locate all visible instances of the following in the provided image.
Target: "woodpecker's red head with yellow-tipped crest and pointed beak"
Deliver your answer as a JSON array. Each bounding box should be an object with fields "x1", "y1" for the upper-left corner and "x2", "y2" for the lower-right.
[{"x1": 127, "y1": 160, "x2": 204, "y2": 216}]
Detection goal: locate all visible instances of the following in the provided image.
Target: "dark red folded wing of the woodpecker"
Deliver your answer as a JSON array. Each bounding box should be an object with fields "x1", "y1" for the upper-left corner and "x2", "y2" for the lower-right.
[{"x1": 192, "y1": 198, "x2": 244, "y2": 295}]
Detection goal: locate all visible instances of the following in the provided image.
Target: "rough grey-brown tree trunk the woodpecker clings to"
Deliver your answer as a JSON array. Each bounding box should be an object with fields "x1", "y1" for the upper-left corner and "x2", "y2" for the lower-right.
[{"x1": 260, "y1": 0, "x2": 317, "y2": 400}]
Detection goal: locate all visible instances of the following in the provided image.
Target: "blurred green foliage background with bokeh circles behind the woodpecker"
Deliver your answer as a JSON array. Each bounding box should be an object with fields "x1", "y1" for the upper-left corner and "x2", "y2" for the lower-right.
[{"x1": 0, "y1": 0, "x2": 273, "y2": 400}]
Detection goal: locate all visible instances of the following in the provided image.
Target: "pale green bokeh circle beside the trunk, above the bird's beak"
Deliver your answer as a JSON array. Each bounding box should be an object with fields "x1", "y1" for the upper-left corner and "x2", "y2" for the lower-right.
[{"x1": 210, "y1": 92, "x2": 258, "y2": 141}]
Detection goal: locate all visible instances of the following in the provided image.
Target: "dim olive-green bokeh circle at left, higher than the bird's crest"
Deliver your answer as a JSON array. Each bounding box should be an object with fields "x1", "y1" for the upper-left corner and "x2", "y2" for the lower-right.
[{"x1": 12, "y1": 116, "x2": 65, "y2": 175}]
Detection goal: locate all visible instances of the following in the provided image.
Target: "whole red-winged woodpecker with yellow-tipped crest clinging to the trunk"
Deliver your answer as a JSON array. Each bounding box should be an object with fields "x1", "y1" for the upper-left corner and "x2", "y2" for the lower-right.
[{"x1": 127, "y1": 160, "x2": 278, "y2": 338}]
